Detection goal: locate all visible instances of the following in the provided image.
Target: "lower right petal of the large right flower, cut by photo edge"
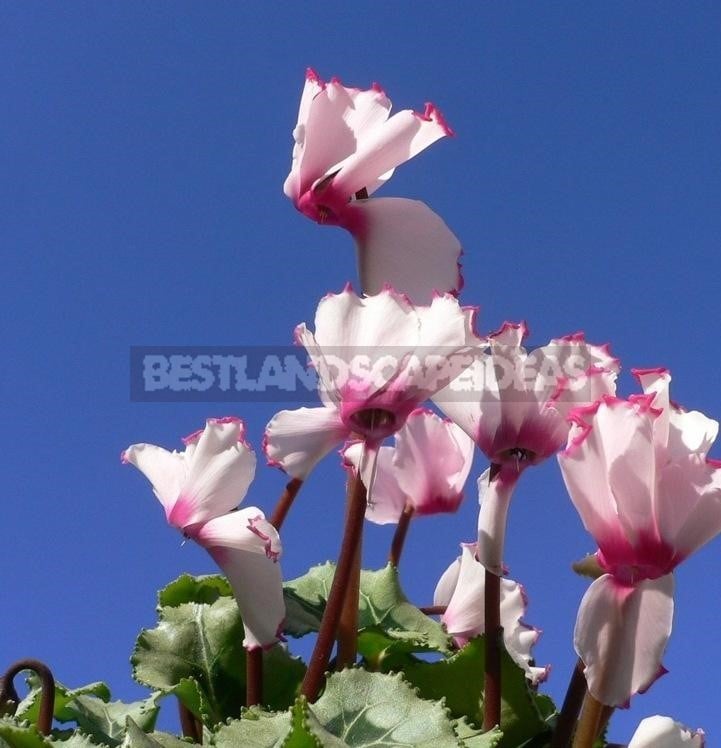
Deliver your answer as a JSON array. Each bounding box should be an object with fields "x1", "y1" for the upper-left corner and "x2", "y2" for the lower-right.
[{"x1": 657, "y1": 455, "x2": 721, "y2": 563}]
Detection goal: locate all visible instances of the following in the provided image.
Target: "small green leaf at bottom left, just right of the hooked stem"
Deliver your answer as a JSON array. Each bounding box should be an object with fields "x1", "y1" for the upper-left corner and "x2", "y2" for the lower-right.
[{"x1": 61, "y1": 695, "x2": 158, "y2": 746}]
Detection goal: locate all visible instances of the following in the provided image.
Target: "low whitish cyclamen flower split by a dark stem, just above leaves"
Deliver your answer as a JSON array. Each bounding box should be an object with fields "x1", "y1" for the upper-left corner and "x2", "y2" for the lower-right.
[{"x1": 433, "y1": 543, "x2": 549, "y2": 684}]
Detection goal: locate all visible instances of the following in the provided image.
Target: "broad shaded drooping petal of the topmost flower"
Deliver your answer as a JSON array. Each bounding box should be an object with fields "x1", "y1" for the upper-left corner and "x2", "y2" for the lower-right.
[{"x1": 341, "y1": 197, "x2": 462, "y2": 304}]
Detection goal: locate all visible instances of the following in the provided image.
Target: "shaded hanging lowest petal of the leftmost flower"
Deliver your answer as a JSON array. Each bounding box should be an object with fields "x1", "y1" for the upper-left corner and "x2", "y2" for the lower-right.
[{"x1": 208, "y1": 533, "x2": 285, "y2": 649}]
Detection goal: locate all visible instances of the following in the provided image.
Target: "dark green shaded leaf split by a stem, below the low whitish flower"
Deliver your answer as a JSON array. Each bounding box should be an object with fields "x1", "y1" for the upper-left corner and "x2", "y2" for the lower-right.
[{"x1": 403, "y1": 636, "x2": 548, "y2": 748}]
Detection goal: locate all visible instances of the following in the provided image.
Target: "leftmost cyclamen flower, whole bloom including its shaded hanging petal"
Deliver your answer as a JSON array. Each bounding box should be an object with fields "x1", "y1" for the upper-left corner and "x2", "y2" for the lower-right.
[{"x1": 122, "y1": 417, "x2": 285, "y2": 649}]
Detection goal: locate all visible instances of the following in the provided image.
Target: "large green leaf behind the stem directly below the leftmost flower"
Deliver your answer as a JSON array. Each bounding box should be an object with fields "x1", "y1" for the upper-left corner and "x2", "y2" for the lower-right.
[{"x1": 131, "y1": 596, "x2": 305, "y2": 727}]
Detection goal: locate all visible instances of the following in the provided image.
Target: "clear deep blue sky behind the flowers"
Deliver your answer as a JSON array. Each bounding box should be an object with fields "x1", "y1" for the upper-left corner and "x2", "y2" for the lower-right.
[{"x1": 0, "y1": 0, "x2": 721, "y2": 745}]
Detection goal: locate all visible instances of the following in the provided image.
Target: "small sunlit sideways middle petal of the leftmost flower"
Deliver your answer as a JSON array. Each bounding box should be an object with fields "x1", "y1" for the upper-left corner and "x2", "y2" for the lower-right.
[{"x1": 193, "y1": 506, "x2": 283, "y2": 560}]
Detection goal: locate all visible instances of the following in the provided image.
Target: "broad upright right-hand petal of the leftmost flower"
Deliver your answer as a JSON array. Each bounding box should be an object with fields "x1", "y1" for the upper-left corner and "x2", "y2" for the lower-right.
[{"x1": 168, "y1": 418, "x2": 256, "y2": 527}]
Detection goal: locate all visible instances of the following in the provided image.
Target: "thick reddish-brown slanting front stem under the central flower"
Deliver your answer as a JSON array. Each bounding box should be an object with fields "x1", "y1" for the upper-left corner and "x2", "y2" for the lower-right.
[{"x1": 301, "y1": 470, "x2": 366, "y2": 701}]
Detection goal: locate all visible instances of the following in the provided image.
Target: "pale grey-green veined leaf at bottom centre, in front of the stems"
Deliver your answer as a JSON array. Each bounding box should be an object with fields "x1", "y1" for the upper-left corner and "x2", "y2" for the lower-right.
[{"x1": 310, "y1": 669, "x2": 460, "y2": 748}]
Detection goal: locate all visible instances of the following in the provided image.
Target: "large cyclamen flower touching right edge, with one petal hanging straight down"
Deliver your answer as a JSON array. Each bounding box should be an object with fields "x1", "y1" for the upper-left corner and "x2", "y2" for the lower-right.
[{"x1": 559, "y1": 369, "x2": 721, "y2": 706}]
